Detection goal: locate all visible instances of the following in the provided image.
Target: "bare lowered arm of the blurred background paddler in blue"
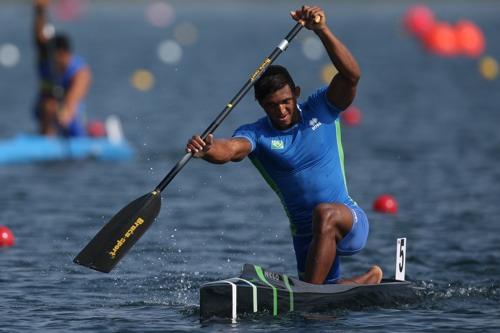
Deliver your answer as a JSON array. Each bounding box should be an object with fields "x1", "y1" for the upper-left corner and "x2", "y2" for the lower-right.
[{"x1": 59, "y1": 67, "x2": 92, "y2": 126}]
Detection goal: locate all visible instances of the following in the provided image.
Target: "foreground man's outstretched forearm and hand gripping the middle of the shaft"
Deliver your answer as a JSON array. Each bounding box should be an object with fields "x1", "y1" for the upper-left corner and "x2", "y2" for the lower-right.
[{"x1": 186, "y1": 134, "x2": 252, "y2": 164}]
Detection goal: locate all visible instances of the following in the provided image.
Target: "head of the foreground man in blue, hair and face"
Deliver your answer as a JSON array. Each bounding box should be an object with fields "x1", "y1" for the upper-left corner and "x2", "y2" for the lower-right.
[{"x1": 254, "y1": 65, "x2": 300, "y2": 129}]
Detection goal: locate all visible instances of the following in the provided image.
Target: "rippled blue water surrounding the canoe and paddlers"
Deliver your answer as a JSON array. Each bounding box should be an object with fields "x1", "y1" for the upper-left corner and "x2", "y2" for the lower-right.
[{"x1": 0, "y1": 2, "x2": 500, "y2": 332}]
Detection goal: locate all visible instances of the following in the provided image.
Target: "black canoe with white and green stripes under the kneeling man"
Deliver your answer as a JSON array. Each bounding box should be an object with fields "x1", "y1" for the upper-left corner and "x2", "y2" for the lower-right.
[{"x1": 200, "y1": 264, "x2": 415, "y2": 320}]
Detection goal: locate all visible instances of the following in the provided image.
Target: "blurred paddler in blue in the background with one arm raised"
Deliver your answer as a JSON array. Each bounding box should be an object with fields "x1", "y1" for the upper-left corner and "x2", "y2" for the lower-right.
[{"x1": 34, "y1": 0, "x2": 91, "y2": 136}]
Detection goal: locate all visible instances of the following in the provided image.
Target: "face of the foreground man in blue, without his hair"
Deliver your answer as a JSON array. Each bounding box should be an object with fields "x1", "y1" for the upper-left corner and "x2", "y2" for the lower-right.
[{"x1": 260, "y1": 85, "x2": 300, "y2": 130}]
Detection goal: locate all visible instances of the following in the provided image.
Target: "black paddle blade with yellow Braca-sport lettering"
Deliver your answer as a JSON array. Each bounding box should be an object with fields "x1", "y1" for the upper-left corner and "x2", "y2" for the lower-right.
[{"x1": 73, "y1": 191, "x2": 161, "y2": 273}]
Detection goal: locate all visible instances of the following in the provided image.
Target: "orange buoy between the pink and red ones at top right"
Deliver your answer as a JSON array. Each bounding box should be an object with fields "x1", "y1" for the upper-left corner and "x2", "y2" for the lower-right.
[{"x1": 424, "y1": 22, "x2": 459, "y2": 56}]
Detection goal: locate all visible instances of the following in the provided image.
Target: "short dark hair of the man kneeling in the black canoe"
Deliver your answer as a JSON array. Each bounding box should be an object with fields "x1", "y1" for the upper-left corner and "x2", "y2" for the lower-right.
[{"x1": 254, "y1": 65, "x2": 295, "y2": 103}]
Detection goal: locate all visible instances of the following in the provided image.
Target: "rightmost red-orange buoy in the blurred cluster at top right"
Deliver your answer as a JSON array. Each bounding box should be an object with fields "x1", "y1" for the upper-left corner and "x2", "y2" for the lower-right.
[{"x1": 455, "y1": 20, "x2": 486, "y2": 57}]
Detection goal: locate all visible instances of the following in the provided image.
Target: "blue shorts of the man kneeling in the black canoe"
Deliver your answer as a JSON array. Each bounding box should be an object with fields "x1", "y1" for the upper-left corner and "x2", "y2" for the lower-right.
[{"x1": 293, "y1": 205, "x2": 370, "y2": 284}]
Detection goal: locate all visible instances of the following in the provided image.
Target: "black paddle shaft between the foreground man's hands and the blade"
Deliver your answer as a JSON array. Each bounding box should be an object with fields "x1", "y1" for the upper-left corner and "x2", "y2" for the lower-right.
[{"x1": 155, "y1": 23, "x2": 303, "y2": 192}]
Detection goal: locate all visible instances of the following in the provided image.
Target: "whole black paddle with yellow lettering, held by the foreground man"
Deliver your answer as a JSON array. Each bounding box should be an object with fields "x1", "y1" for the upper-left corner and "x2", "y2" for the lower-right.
[{"x1": 73, "y1": 23, "x2": 302, "y2": 273}]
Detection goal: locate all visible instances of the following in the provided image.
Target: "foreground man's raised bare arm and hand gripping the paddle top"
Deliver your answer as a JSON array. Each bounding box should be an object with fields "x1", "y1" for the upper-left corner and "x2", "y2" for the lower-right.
[{"x1": 291, "y1": 6, "x2": 361, "y2": 110}]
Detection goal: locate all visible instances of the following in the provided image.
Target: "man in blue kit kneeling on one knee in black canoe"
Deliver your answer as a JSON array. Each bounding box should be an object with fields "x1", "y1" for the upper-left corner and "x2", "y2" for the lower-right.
[{"x1": 186, "y1": 6, "x2": 382, "y2": 284}]
